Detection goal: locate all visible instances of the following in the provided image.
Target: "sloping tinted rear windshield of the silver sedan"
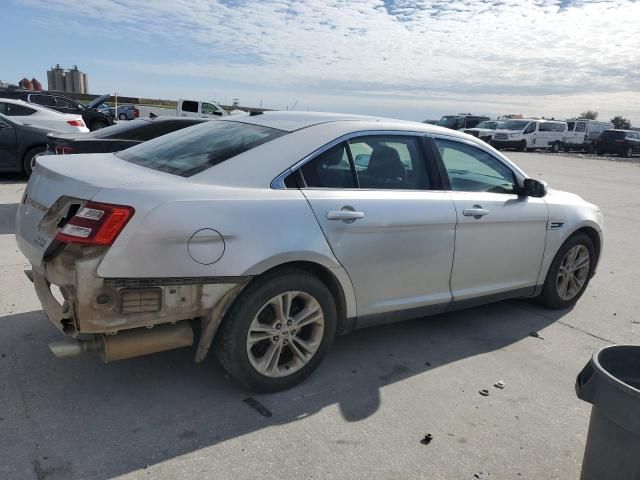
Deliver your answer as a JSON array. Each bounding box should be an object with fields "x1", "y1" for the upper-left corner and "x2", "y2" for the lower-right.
[{"x1": 117, "y1": 120, "x2": 287, "y2": 177}]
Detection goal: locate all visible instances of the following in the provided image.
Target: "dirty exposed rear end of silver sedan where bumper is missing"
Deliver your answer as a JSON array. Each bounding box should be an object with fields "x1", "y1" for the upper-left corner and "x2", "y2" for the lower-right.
[{"x1": 25, "y1": 247, "x2": 250, "y2": 360}]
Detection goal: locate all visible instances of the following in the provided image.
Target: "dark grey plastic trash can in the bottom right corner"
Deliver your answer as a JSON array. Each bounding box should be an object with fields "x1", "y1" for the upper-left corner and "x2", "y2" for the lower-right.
[{"x1": 576, "y1": 345, "x2": 640, "y2": 480}]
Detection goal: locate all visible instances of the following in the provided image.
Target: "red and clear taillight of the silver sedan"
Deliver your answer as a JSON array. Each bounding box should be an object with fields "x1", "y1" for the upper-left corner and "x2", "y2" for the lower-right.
[{"x1": 55, "y1": 202, "x2": 135, "y2": 245}]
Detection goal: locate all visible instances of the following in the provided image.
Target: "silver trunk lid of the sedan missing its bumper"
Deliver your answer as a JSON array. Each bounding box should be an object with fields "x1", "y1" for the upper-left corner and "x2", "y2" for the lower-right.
[{"x1": 16, "y1": 153, "x2": 180, "y2": 268}]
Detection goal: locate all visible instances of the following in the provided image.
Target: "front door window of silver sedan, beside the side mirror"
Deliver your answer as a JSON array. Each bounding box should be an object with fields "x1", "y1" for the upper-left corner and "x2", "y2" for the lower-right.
[{"x1": 436, "y1": 138, "x2": 517, "y2": 194}]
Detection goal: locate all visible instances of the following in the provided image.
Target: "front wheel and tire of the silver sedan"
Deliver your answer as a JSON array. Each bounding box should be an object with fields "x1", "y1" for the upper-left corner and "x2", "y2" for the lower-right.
[{"x1": 538, "y1": 233, "x2": 596, "y2": 309}]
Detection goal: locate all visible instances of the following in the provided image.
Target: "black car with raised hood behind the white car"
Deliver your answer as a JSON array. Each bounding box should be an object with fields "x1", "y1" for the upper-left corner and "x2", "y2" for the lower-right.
[{"x1": 0, "y1": 89, "x2": 113, "y2": 131}]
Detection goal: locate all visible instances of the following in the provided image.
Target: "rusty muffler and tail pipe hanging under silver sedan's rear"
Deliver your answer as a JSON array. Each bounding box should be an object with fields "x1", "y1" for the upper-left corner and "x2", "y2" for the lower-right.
[{"x1": 49, "y1": 321, "x2": 193, "y2": 362}]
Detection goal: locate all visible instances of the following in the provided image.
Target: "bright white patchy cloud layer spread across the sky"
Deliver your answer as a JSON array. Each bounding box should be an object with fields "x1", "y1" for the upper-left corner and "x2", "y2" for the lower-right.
[{"x1": 16, "y1": 0, "x2": 640, "y2": 119}]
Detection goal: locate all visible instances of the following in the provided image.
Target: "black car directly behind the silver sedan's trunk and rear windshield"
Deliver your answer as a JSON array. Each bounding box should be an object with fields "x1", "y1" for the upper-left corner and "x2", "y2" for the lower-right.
[{"x1": 47, "y1": 117, "x2": 208, "y2": 155}]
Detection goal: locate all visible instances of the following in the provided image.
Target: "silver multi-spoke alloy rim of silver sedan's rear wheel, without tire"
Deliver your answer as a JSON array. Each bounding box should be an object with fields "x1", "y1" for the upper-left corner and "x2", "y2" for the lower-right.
[{"x1": 247, "y1": 291, "x2": 325, "y2": 378}]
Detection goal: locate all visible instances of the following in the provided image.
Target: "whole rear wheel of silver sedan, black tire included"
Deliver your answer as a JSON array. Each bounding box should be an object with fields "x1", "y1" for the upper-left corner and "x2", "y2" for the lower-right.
[{"x1": 215, "y1": 269, "x2": 337, "y2": 392}]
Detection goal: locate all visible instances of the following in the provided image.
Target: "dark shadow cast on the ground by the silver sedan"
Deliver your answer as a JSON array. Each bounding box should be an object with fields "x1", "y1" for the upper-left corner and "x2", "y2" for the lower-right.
[{"x1": 0, "y1": 301, "x2": 567, "y2": 480}]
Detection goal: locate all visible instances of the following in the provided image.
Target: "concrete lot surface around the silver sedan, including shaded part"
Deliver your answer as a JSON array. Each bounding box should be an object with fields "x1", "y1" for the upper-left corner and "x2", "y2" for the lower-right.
[{"x1": 0, "y1": 153, "x2": 640, "y2": 480}]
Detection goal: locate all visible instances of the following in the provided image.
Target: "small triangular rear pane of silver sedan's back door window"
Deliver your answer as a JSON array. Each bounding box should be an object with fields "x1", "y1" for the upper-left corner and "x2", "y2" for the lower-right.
[{"x1": 301, "y1": 142, "x2": 357, "y2": 188}]
